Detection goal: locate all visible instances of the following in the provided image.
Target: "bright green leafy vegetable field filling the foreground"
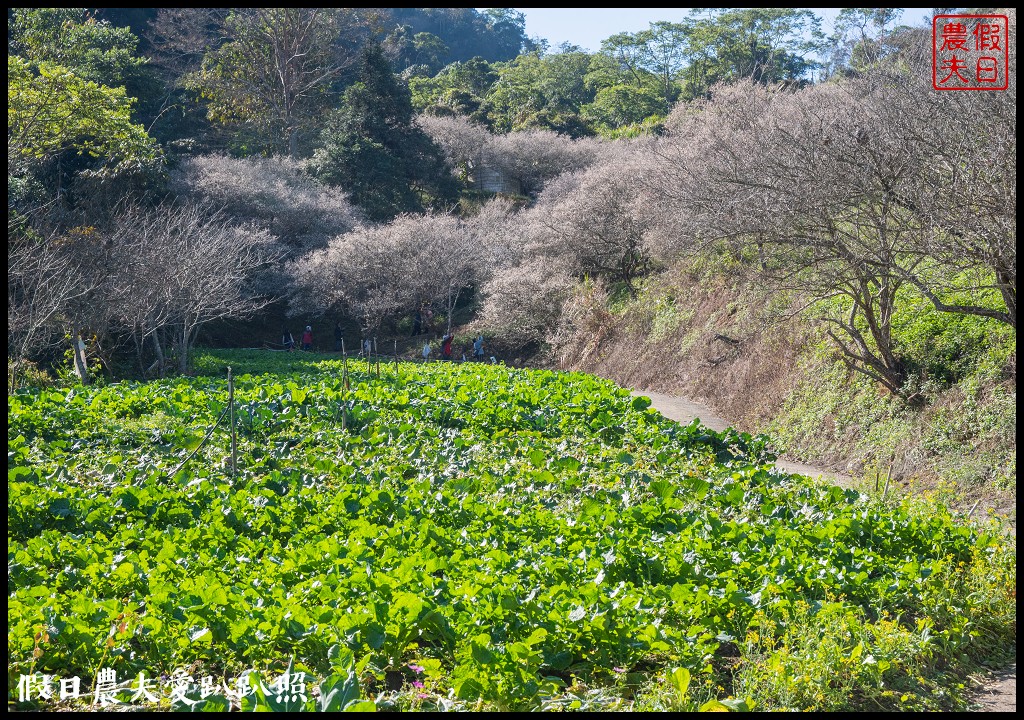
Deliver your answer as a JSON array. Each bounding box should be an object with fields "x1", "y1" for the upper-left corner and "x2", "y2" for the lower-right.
[{"x1": 7, "y1": 351, "x2": 1016, "y2": 711}]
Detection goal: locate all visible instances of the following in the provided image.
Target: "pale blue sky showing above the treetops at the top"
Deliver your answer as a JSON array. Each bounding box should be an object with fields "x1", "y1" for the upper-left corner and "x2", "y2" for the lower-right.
[{"x1": 514, "y1": 7, "x2": 929, "y2": 52}]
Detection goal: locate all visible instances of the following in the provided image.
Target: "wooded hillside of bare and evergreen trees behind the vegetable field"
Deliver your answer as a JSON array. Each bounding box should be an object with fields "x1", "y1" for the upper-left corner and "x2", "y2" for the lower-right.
[{"x1": 7, "y1": 8, "x2": 1016, "y2": 507}]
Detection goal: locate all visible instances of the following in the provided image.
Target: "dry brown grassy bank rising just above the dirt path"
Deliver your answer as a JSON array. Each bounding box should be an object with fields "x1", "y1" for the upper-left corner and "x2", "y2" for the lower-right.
[{"x1": 555, "y1": 274, "x2": 806, "y2": 429}]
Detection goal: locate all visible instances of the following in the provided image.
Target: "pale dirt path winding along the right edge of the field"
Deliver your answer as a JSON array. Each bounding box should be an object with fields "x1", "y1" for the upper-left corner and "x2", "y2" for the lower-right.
[{"x1": 633, "y1": 390, "x2": 1017, "y2": 713}]
